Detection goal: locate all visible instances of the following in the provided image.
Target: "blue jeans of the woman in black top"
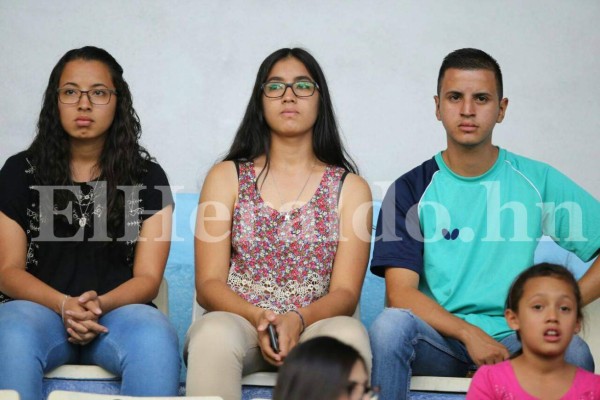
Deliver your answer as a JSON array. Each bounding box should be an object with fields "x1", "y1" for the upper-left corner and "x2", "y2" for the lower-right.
[{"x1": 0, "y1": 300, "x2": 181, "y2": 400}]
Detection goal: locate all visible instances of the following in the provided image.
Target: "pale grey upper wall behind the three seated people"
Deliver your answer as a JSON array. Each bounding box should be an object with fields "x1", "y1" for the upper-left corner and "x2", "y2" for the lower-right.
[{"x1": 0, "y1": 0, "x2": 600, "y2": 198}]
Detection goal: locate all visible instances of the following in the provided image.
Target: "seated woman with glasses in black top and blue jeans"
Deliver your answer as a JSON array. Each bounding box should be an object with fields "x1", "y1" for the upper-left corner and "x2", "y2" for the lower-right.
[{"x1": 0, "y1": 47, "x2": 180, "y2": 400}]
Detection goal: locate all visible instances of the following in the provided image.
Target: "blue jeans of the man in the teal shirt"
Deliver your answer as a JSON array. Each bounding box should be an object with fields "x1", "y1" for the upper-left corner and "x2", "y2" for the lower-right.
[{"x1": 369, "y1": 308, "x2": 594, "y2": 400}]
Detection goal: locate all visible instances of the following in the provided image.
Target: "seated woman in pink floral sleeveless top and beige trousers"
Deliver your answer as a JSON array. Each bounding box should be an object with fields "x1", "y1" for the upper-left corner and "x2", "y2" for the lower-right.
[{"x1": 186, "y1": 49, "x2": 372, "y2": 400}]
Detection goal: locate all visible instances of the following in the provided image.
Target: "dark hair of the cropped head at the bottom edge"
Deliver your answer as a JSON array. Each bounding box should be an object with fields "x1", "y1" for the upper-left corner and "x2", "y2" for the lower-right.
[{"x1": 273, "y1": 336, "x2": 365, "y2": 400}]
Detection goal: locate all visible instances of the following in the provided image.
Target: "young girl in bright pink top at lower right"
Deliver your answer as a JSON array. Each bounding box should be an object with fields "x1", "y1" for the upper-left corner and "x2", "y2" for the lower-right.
[{"x1": 467, "y1": 263, "x2": 600, "y2": 400}]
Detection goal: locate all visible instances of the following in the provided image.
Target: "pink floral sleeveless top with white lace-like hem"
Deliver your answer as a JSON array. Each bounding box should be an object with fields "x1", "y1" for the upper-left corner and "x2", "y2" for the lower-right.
[{"x1": 227, "y1": 162, "x2": 345, "y2": 313}]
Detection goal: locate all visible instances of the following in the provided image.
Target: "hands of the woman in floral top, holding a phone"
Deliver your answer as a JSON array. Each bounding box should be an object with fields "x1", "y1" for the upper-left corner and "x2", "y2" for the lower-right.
[{"x1": 256, "y1": 310, "x2": 302, "y2": 367}]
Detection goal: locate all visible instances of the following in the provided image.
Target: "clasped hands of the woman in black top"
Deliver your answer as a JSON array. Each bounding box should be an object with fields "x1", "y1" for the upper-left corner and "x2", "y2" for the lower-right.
[{"x1": 62, "y1": 290, "x2": 108, "y2": 346}]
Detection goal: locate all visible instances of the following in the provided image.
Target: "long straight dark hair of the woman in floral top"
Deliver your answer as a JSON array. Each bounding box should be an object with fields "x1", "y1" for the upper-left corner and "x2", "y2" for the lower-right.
[{"x1": 223, "y1": 48, "x2": 358, "y2": 174}]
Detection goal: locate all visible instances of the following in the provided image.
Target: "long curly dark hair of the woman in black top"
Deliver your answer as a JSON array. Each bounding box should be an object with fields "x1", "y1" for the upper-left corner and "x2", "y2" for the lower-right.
[{"x1": 27, "y1": 46, "x2": 152, "y2": 236}]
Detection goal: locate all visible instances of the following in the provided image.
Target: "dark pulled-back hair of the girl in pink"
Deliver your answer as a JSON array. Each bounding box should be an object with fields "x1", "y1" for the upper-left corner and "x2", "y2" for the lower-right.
[{"x1": 505, "y1": 263, "x2": 583, "y2": 321}]
